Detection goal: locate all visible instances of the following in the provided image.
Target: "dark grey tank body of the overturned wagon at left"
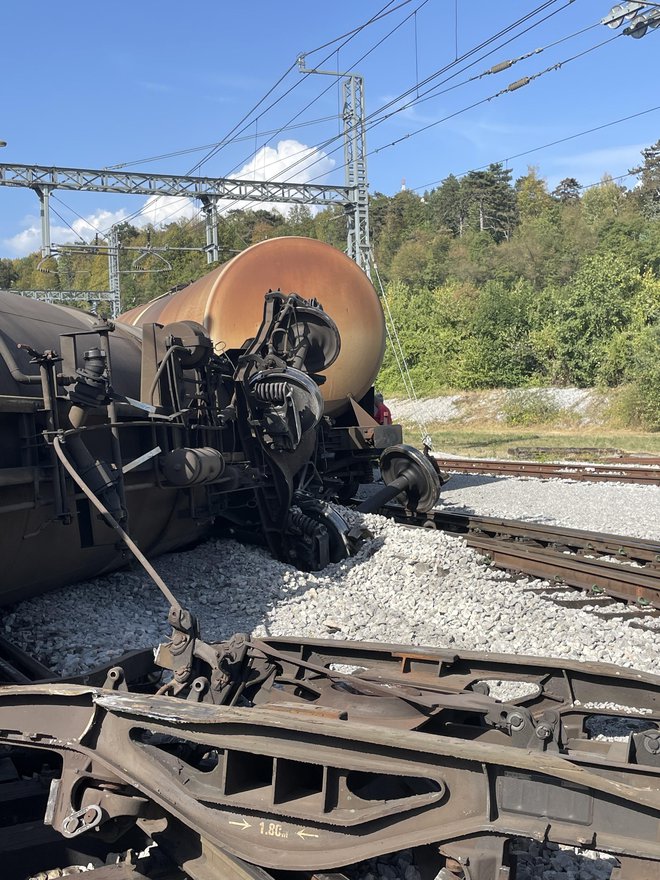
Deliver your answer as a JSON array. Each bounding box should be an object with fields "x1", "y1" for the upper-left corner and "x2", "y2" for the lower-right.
[{"x1": 0, "y1": 293, "x2": 210, "y2": 604}]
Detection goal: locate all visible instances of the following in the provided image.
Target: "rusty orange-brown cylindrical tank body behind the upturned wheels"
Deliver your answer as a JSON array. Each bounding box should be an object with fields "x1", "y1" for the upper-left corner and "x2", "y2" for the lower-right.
[{"x1": 119, "y1": 237, "x2": 385, "y2": 415}]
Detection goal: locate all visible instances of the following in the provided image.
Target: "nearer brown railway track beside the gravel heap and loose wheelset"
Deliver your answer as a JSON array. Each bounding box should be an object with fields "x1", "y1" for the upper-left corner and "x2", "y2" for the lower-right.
[{"x1": 382, "y1": 504, "x2": 660, "y2": 623}]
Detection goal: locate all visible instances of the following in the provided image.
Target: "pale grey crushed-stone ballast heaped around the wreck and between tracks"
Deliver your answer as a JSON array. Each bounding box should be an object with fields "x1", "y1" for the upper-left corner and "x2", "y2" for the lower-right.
[{"x1": 2, "y1": 475, "x2": 660, "y2": 880}]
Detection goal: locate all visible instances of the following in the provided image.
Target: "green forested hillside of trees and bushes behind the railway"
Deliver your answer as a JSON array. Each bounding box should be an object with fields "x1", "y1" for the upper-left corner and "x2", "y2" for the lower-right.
[{"x1": 0, "y1": 141, "x2": 660, "y2": 430}]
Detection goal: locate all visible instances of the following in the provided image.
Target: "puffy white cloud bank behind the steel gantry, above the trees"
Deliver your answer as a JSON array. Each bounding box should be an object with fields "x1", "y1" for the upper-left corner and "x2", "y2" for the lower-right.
[{"x1": 0, "y1": 139, "x2": 336, "y2": 257}]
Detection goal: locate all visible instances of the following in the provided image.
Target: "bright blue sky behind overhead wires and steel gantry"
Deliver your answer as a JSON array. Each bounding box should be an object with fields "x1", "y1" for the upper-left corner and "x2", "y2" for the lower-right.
[{"x1": 0, "y1": 0, "x2": 660, "y2": 257}]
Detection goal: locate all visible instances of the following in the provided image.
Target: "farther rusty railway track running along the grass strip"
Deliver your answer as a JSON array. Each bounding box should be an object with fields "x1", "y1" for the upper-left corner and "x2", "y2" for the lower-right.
[{"x1": 434, "y1": 455, "x2": 660, "y2": 485}]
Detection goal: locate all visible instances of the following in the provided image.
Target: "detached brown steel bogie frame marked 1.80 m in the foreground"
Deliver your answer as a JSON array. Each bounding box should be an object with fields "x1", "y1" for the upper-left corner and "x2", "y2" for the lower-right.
[{"x1": 0, "y1": 624, "x2": 660, "y2": 880}]
